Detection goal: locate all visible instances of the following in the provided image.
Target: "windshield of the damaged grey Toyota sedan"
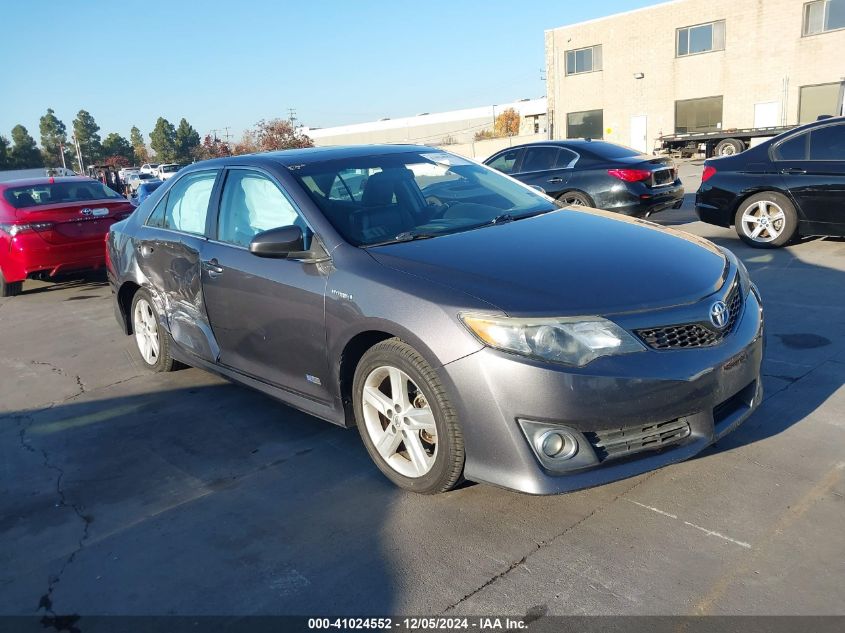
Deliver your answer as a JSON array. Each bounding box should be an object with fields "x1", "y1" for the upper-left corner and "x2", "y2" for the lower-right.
[{"x1": 291, "y1": 150, "x2": 557, "y2": 246}]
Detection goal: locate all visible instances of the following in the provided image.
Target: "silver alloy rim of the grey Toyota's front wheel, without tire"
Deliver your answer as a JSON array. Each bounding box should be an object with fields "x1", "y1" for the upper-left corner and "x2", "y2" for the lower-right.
[{"x1": 361, "y1": 365, "x2": 437, "y2": 478}]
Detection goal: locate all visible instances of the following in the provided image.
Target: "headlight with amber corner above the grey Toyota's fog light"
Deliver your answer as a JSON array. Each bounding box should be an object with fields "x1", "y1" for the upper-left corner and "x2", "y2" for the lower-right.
[{"x1": 460, "y1": 314, "x2": 645, "y2": 367}]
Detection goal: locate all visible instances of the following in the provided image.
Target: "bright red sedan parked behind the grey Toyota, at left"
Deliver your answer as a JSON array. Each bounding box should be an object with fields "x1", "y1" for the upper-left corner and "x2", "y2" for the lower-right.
[{"x1": 0, "y1": 176, "x2": 133, "y2": 297}]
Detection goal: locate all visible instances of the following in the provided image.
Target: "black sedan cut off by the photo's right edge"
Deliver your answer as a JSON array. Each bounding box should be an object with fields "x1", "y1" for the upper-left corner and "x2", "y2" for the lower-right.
[{"x1": 695, "y1": 117, "x2": 845, "y2": 248}]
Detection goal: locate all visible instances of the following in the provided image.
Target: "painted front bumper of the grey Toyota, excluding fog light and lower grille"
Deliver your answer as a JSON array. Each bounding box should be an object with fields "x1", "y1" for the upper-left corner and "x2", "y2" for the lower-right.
[{"x1": 440, "y1": 292, "x2": 763, "y2": 494}]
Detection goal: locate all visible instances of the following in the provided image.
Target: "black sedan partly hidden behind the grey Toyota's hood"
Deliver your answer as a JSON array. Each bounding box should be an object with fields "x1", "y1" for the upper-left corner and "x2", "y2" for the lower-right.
[{"x1": 484, "y1": 139, "x2": 684, "y2": 218}]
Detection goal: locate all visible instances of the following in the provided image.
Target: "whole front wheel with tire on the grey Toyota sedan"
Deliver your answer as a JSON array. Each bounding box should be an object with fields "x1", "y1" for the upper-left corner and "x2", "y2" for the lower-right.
[{"x1": 352, "y1": 338, "x2": 464, "y2": 494}]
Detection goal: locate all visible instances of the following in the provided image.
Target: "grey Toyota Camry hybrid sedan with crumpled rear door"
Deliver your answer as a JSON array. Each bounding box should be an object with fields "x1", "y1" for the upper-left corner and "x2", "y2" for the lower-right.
[{"x1": 106, "y1": 146, "x2": 763, "y2": 494}]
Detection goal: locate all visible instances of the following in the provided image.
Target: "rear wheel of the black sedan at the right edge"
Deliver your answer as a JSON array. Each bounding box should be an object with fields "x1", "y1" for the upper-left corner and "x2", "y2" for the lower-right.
[{"x1": 734, "y1": 191, "x2": 798, "y2": 248}]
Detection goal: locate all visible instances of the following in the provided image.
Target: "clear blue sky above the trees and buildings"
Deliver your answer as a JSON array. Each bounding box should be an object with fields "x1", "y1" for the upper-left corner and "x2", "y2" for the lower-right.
[{"x1": 0, "y1": 0, "x2": 656, "y2": 140}]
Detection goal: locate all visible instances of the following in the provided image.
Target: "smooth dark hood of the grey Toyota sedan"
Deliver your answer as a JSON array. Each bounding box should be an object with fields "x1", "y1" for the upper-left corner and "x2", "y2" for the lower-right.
[{"x1": 369, "y1": 209, "x2": 728, "y2": 316}]
